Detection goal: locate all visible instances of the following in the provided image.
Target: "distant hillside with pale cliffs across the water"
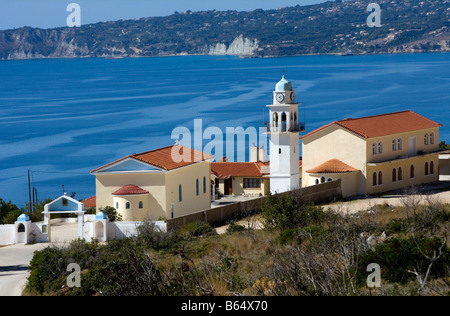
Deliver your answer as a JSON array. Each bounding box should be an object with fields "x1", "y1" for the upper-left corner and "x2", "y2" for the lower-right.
[{"x1": 0, "y1": 0, "x2": 450, "y2": 59}]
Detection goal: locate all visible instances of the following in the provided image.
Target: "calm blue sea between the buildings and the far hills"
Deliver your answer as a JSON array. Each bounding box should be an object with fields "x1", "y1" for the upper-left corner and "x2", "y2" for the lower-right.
[{"x1": 0, "y1": 54, "x2": 450, "y2": 206}]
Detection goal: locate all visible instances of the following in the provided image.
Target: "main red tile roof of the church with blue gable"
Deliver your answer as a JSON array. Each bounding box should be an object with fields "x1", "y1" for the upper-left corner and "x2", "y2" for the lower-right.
[{"x1": 91, "y1": 145, "x2": 214, "y2": 173}]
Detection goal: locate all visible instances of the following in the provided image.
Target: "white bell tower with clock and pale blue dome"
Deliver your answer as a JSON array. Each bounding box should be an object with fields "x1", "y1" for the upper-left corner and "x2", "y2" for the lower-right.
[{"x1": 268, "y1": 75, "x2": 300, "y2": 194}]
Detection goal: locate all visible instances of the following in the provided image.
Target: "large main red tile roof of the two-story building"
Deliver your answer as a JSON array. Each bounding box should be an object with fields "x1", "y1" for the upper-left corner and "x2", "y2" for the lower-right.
[{"x1": 301, "y1": 111, "x2": 442, "y2": 139}]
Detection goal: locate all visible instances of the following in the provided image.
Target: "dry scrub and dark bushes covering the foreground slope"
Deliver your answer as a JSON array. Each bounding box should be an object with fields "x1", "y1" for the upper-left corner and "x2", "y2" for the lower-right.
[{"x1": 26, "y1": 191, "x2": 450, "y2": 296}]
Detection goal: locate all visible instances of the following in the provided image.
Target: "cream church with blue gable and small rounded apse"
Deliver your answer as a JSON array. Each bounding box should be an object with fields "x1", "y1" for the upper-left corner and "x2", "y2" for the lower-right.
[{"x1": 91, "y1": 145, "x2": 213, "y2": 221}]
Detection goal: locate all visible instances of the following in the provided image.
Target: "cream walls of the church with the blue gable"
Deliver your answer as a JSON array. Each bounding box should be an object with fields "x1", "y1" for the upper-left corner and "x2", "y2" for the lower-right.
[{"x1": 96, "y1": 161, "x2": 211, "y2": 221}]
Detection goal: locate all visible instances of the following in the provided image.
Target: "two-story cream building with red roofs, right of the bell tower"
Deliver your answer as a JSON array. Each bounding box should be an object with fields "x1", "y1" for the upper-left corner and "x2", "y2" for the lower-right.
[{"x1": 301, "y1": 111, "x2": 442, "y2": 197}]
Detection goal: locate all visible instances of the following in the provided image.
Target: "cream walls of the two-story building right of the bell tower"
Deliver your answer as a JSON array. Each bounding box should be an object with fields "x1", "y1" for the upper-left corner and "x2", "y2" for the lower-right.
[{"x1": 302, "y1": 125, "x2": 439, "y2": 196}]
